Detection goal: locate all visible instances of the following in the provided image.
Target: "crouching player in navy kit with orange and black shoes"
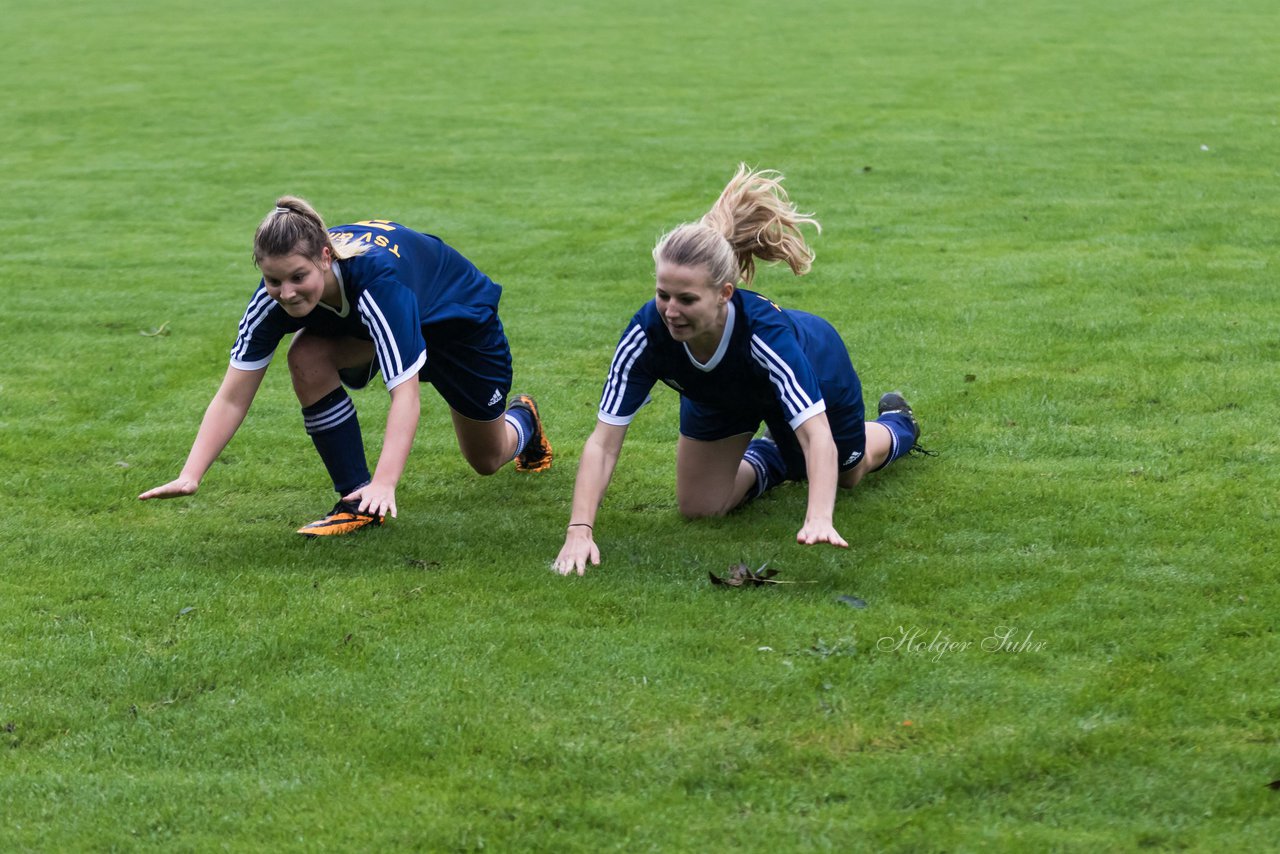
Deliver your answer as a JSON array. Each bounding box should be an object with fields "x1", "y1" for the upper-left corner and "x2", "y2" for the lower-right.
[{"x1": 138, "y1": 196, "x2": 552, "y2": 536}]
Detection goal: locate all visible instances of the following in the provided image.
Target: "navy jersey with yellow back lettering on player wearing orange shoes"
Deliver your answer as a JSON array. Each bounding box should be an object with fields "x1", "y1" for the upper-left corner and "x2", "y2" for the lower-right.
[{"x1": 232, "y1": 220, "x2": 502, "y2": 389}]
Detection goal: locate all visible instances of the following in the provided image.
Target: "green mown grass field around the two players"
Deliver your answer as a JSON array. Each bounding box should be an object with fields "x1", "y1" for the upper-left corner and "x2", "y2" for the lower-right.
[{"x1": 0, "y1": 0, "x2": 1280, "y2": 851}]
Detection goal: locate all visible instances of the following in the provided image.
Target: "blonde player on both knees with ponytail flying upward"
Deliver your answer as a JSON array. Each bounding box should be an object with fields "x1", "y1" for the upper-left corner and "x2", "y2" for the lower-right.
[{"x1": 553, "y1": 165, "x2": 920, "y2": 575}]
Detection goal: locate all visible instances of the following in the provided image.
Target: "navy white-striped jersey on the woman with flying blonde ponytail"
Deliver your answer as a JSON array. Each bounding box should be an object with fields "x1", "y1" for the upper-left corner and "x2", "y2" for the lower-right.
[{"x1": 599, "y1": 288, "x2": 861, "y2": 430}]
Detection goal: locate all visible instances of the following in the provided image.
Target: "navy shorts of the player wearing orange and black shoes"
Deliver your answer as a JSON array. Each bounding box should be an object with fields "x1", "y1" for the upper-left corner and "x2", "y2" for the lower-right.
[{"x1": 338, "y1": 314, "x2": 512, "y2": 421}]
